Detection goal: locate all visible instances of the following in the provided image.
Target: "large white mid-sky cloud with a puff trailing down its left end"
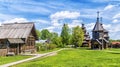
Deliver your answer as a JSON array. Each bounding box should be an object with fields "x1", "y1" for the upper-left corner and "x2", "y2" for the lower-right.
[{"x1": 50, "y1": 11, "x2": 80, "y2": 27}]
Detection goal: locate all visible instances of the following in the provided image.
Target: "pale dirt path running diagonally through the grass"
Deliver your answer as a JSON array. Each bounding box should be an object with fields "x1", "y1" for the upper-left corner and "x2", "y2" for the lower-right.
[{"x1": 0, "y1": 48, "x2": 64, "y2": 67}]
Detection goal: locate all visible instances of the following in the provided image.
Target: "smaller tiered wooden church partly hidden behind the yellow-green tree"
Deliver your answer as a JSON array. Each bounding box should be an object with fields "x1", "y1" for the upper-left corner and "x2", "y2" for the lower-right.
[{"x1": 82, "y1": 24, "x2": 91, "y2": 47}]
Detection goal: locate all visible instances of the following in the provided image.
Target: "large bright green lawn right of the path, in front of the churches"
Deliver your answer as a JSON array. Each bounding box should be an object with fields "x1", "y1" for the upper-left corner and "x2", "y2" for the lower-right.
[{"x1": 13, "y1": 48, "x2": 120, "y2": 67}]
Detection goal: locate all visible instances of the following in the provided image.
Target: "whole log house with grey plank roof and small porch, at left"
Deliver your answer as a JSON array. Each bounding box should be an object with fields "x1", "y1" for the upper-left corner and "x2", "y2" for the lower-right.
[{"x1": 0, "y1": 22, "x2": 38, "y2": 56}]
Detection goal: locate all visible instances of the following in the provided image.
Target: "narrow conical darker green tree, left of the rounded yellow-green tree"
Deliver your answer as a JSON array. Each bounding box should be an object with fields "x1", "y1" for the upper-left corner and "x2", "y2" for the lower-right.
[{"x1": 61, "y1": 24, "x2": 70, "y2": 45}]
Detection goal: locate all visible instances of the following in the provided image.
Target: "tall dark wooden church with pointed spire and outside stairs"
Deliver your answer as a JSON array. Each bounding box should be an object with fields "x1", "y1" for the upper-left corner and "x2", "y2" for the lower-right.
[{"x1": 91, "y1": 12, "x2": 109, "y2": 49}]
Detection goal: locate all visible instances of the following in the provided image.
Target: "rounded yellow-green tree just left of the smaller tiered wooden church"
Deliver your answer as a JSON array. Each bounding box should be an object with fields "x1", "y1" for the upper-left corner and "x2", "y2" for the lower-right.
[{"x1": 72, "y1": 26, "x2": 84, "y2": 47}]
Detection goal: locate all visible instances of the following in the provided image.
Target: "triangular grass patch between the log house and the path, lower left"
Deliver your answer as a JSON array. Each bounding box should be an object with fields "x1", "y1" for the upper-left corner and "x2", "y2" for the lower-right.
[{"x1": 0, "y1": 55, "x2": 31, "y2": 65}]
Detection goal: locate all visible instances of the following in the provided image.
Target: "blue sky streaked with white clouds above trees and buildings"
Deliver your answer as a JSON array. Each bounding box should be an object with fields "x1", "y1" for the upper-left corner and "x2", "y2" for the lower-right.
[{"x1": 0, "y1": 0, "x2": 120, "y2": 39}]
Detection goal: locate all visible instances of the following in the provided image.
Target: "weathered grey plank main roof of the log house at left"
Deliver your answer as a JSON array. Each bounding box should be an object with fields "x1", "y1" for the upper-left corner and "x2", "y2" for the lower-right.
[{"x1": 0, "y1": 22, "x2": 37, "y2": 39}]
